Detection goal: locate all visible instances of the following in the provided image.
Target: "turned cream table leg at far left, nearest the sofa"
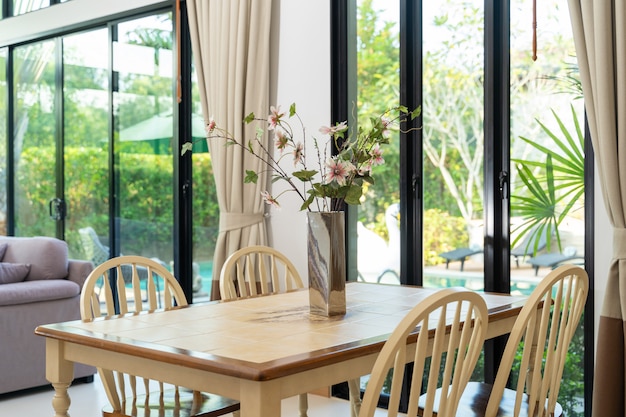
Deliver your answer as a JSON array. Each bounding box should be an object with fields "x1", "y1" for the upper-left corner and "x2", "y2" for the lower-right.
[{"x1": 46, "y1": 339, "x2": 74, "y2": 417}]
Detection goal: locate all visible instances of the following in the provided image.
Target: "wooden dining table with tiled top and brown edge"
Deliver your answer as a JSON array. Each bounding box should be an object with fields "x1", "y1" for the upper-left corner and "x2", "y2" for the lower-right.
[{"x1": 35, "y1": 282, "x2": 525, "y2": 417}]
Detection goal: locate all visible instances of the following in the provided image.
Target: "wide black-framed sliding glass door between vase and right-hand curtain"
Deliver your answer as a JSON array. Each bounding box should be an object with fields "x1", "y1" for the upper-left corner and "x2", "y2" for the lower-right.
[{"x1": 346, "y1": 0, "x2": 585, "y2": 415}]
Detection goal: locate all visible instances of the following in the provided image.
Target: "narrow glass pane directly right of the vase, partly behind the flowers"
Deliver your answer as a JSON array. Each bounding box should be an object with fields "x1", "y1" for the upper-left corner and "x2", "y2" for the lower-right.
[{"x1": 357, "y1": 0, "x2": 400, "y2": 284}]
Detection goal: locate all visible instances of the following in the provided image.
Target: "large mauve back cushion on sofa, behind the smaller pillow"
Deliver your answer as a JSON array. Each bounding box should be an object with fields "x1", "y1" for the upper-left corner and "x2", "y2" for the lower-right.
[{"x1": 0, "y1": 236, "x2": 68, "y2": 281}]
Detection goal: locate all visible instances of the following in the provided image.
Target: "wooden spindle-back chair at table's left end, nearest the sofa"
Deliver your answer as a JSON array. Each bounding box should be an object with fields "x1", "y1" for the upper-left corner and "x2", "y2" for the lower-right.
[{"x1": 80, "y1": 256, "x2": 239, "y2": 417}]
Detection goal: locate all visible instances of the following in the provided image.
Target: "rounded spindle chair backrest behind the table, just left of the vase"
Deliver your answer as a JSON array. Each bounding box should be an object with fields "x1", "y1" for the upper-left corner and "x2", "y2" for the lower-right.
[{"x1": 220, "y1": 246, "x2": 304, "y2": 300}]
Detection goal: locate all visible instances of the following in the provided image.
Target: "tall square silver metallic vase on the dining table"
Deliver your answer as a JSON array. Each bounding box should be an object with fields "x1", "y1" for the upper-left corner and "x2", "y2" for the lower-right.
[{"x1": 307, "y1": 211, "x2": 346, "y2": 317}]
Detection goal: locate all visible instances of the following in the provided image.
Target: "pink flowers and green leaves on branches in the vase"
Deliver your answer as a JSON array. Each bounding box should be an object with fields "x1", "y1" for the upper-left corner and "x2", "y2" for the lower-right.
[{"x1": 182, "y1": 103, "x2": 421, "y2": 211}]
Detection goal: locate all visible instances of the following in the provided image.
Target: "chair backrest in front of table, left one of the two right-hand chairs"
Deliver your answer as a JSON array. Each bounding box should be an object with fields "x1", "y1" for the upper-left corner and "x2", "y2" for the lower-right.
[{"x1": 359, "y1": 288, "x2": 488, "y2": 417}]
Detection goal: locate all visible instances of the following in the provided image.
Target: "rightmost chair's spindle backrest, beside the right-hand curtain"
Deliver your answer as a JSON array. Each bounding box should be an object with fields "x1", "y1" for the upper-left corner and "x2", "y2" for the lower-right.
[{"x1": 485, "y1": 265, "x2": 589, "y2": 417}]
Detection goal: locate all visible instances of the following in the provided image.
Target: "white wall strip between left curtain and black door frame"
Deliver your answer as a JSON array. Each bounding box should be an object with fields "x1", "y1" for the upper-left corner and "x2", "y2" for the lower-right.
[{"x1": 268, "y1": 0, "x2": 330, "y2": 280}]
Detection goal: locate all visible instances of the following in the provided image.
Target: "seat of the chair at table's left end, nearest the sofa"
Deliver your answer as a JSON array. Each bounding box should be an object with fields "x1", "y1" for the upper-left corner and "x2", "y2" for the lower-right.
[{"x1": 102, "y1": 388, "x2": 239, "y2": 417}]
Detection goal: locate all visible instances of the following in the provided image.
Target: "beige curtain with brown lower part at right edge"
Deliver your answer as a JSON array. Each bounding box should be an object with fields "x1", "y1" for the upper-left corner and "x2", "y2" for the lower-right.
[{"x1": 569, "y1": 0, "x2": 626, "y2": 417}]
